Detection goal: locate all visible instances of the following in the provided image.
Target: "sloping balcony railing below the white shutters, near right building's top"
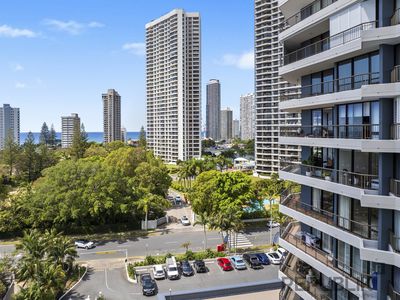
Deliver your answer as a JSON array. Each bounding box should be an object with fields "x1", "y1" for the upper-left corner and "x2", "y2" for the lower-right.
[{"x1": 283, "y1": 21, "x2": 376, "y2": 65}]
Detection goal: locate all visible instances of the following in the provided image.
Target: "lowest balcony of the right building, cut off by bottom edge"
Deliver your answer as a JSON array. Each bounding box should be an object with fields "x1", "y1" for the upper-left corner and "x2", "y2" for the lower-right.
[{"x1": 280, "y1": 254, "x2": 332, "y2": 300}]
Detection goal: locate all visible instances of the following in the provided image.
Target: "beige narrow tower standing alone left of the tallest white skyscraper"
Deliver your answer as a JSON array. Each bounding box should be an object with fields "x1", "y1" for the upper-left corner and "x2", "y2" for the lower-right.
[{"x1": 102, "y1": 89, "x2": 121, "y2": 143}]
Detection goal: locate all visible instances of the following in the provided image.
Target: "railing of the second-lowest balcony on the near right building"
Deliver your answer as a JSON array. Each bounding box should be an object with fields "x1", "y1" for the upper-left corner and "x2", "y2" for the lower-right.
[{"x1": 281, "y1": 222, "x2": 372, "y2": 288}]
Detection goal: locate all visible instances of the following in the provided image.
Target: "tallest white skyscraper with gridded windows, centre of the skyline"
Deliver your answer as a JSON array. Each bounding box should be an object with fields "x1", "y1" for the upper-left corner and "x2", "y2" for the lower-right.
[{"x1": 146, "y1": 9, "x2": 201, "y2": 162}]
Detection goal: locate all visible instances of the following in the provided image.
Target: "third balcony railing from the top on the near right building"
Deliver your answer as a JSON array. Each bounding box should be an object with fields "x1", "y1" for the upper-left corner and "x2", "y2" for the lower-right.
[{"x1": 279, "y1": 72, "x2": 380, "y2": 101}]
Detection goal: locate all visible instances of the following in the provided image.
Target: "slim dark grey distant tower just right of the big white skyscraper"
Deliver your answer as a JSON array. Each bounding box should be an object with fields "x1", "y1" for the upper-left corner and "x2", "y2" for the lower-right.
[{"x1": 206, "y1": 79, "x2": 221, "y2": 141}]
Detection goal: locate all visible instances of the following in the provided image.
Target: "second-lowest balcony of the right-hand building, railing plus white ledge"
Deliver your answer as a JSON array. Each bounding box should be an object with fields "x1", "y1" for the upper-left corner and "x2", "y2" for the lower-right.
[{"x1": 281, "y1": 223, "x2": 372, "y2": 290}]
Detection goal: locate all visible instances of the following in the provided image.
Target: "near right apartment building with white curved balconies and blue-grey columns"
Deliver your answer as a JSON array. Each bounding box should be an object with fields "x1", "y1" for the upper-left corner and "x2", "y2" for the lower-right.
[{"x1": 279, "y1": 0, "x2": 400, "y2": 300}]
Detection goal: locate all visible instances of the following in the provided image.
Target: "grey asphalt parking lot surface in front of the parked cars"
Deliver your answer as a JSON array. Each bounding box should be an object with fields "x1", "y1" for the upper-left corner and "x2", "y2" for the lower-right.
[{"x1": 64, "y1": 260, "x2": 279, "y2": 300}]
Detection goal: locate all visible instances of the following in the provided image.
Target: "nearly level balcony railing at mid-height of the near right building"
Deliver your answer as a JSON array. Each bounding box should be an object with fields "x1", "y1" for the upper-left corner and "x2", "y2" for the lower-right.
[{"x1": 280, "y1": 124, "x2": 380, "y2": 139}]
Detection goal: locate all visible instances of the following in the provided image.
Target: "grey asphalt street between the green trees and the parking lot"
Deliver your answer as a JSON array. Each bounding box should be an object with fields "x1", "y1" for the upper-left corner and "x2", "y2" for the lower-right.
[{"x1": 0, "y1": 226, "x2": 278, "y2": 261}]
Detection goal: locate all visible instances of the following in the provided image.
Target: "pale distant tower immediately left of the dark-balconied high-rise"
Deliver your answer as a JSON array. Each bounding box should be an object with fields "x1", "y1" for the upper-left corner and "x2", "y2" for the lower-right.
[{"x1": 240, "y1": 93, "x2": 256, "y2": 140}]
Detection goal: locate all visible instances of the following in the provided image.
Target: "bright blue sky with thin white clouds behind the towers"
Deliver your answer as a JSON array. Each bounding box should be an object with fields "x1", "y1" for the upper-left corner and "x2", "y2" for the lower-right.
[{"x1": 0, "y1": 0, "x2": 254, "y2": 132}]
